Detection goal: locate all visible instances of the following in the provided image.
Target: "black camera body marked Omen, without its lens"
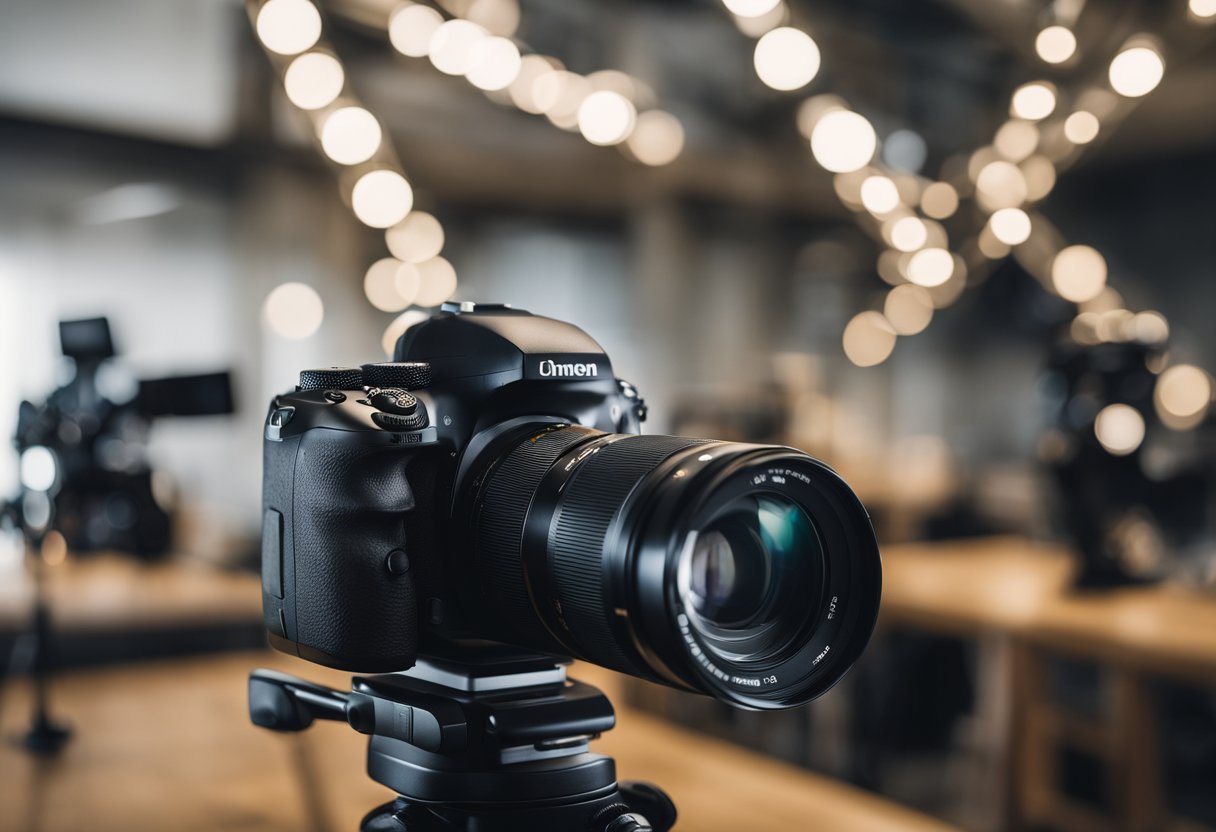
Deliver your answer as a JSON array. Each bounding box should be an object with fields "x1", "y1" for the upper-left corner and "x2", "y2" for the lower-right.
[{"x1": 261, "y1": 303, "x2": 646, "y2": 673}]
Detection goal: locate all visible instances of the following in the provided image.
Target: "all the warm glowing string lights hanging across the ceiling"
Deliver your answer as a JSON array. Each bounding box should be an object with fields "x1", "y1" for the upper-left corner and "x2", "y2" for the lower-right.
[{"x1": 249, "y1": 0, "x2": 1216, "y2": 421}]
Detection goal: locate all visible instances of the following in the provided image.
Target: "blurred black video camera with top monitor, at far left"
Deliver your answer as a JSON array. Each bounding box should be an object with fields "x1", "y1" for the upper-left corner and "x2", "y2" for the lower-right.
[{"x1": 11, "y1": 317, "x2": 233, "y2": 560}]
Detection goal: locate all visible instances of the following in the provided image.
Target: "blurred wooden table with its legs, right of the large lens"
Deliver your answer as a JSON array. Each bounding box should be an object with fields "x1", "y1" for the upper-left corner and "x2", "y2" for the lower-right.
[{"x1": 882, "y1": 538, "x2": 1216, "y2": 831}]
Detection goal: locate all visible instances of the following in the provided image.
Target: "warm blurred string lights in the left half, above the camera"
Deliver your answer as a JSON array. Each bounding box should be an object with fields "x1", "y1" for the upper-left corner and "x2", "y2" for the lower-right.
[{"x1": 247, "y1": 0, "x2": 685, "y2": 353}]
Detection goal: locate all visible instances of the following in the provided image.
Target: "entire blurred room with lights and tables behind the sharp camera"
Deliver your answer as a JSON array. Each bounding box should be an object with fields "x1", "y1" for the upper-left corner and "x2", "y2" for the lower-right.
[{"x1": 0, "y1": 0, "x2": 1216, "y2": 831}]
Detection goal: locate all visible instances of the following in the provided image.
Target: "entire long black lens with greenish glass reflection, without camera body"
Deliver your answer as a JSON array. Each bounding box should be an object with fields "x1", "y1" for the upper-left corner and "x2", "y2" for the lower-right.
[{"x1": 468, "y1": 425, "x2": 882, "y2": 708}]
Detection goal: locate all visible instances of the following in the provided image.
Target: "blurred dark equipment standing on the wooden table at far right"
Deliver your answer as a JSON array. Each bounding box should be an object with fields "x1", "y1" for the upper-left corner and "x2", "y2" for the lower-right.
[{"x1": 1038, "y1": 341, "x2": 1216, "y2": 588}]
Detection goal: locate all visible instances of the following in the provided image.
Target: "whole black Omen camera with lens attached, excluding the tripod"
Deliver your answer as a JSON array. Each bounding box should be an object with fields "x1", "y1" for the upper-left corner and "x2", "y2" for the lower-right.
[{"x1": 261, "y1": 303, "x2": 880, "y2": 709}]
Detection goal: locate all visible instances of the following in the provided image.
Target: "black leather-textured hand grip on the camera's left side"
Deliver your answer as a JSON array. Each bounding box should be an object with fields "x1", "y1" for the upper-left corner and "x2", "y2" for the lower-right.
[{"x1": 285, "y1": 428, "x2": 420, "y2": 673}]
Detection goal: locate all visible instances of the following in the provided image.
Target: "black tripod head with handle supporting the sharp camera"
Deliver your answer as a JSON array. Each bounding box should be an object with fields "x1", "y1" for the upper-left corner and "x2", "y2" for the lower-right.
[{"x1": 249, "y1": 646, "x2": 676, "y2": 832}]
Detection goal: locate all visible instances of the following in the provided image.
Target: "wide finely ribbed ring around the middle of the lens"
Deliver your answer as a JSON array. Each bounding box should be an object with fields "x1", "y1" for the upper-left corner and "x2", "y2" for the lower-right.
[{"x1": 548, "y1": 435, "x2": 705, "y2": 673}]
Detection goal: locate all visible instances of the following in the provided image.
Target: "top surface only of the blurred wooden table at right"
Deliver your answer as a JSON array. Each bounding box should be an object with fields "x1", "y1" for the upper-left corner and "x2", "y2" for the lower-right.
[{"x1": 882, "y1": 538, "x2": 1216, "y2": 684}]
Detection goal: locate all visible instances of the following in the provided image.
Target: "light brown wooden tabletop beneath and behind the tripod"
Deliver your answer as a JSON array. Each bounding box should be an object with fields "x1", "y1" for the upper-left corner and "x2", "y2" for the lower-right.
[{"x1": 0, "y1": 652, "x2": 951, "y2": 832}]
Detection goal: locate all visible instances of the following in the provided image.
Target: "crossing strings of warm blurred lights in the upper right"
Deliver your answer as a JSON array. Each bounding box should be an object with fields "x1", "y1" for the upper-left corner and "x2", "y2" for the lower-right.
[{"x1": 724, "y1": 0, "x2": 1216, "y2": 442}]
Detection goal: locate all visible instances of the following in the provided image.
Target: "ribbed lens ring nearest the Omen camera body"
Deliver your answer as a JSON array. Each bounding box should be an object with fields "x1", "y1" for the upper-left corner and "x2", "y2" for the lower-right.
[{"x1": 477, "y1": 428, "x2": 596, "y2": 652}]
